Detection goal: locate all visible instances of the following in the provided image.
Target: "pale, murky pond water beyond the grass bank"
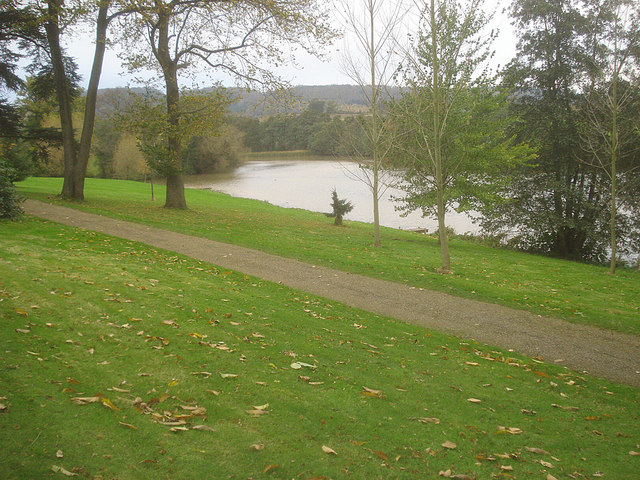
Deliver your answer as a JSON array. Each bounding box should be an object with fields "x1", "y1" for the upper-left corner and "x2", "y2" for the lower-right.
[{"x1": 184, "y1": 155, "x2": 479, "y2": 233}]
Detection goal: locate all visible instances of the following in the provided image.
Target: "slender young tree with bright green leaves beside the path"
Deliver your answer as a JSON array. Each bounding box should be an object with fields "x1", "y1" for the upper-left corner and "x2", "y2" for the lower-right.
[{"x1": 392, "y1": 0, "x2": 529, "y2": 273}]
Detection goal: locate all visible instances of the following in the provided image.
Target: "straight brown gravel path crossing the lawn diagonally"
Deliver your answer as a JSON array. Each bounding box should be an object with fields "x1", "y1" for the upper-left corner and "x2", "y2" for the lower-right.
[{"x1": 24, "y1": 200, "x2": 640, "y2": 387}]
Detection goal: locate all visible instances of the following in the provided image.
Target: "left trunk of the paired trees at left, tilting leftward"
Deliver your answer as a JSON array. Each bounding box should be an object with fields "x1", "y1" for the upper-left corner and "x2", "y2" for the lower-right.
[{"x1": 44, "y1": 0, "x2": 77, "y2": 198}]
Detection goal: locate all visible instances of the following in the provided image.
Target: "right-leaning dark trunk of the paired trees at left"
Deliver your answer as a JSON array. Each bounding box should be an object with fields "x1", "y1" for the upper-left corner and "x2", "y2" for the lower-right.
[{"x1": 71, "y1": 0, "x2": 110, "y2": 200}]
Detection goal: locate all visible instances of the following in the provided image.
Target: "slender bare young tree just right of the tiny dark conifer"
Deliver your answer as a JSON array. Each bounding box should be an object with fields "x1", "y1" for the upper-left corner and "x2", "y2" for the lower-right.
[{"x1": 343, "y1": 0, "x2": 407, "y2": 247}]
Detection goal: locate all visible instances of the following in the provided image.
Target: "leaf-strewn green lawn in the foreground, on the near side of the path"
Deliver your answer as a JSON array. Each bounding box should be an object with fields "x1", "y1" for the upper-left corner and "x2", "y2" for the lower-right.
[{"x1": 0, "y1": 218, "x2": 640, "y2": 480}]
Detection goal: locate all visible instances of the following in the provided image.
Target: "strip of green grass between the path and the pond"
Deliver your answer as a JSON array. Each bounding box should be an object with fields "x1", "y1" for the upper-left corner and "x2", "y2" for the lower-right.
[{"x1": 18, "y1": 178, "x2": 640, "y2": 335}]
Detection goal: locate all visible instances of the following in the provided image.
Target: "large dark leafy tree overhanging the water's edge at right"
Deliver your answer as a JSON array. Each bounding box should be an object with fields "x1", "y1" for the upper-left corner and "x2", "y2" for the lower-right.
[{"x1": 483, "y1": 0, "x2": 636, "y2": 262}]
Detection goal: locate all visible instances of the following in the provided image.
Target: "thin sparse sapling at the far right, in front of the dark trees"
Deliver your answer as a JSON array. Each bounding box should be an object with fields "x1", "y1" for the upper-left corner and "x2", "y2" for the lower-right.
[{"x1": 580, "y1": 0, "x2": 640, "y2": 274}]
